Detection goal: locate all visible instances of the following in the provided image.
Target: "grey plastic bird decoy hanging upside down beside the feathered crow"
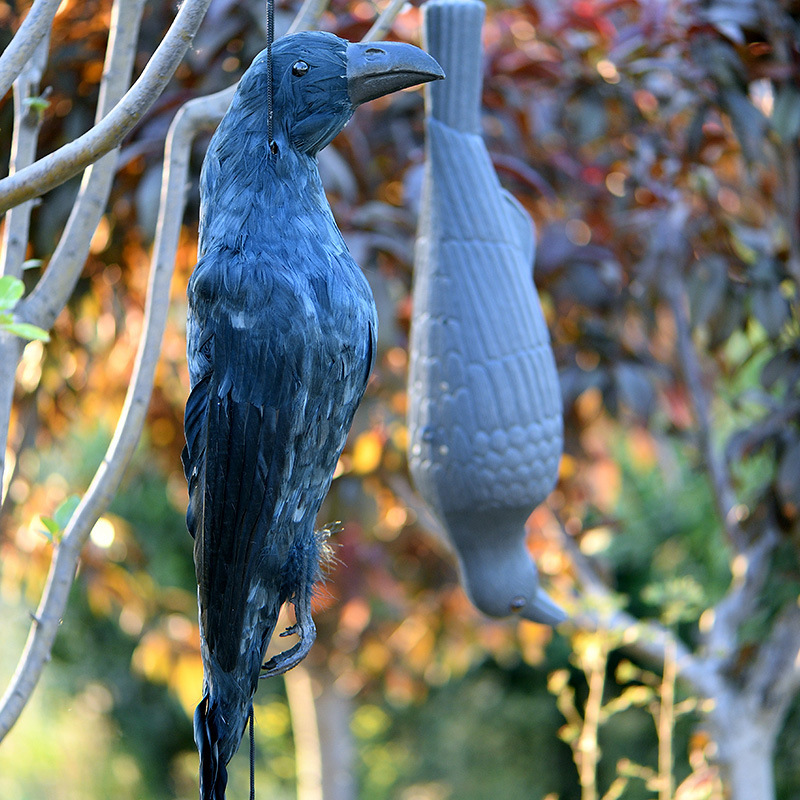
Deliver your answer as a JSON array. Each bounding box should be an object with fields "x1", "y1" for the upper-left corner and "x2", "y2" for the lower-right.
[{"x1": 408, "y1": 0, "x2": 565, "y2": 624}]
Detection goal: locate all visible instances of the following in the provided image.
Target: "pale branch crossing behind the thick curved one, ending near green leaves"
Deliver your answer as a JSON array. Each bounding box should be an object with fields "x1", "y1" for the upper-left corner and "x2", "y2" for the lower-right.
[{"x1": 20, "y1": 0, "x2": 144, "y2": 330}]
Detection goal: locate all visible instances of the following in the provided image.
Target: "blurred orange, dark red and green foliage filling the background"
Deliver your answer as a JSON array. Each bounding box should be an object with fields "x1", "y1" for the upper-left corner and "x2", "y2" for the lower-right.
[{"x1": 0, "y1": 0, "x2": 800, "y2": 800}]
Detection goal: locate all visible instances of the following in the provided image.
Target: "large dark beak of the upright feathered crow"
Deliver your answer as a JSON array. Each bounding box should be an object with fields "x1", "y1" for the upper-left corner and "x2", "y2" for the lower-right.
[{"x1": 347, "y1": 42, "x2": 444, "y2": 106}]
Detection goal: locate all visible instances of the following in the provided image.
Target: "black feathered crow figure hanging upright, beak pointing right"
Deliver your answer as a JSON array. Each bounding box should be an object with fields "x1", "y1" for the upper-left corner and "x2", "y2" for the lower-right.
[{"x1": 183, "y1": 32, "x2": 443, "y2": 800}]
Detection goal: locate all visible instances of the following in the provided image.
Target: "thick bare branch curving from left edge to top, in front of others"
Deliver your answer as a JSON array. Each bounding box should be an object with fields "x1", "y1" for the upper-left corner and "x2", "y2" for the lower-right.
[{"x1": 0, "y1": 0, "x2": 211, "y2": 212}]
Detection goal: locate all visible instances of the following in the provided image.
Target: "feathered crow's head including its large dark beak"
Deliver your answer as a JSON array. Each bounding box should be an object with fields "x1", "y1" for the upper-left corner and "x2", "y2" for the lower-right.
[{"x1": 239, "y1": 31, "x2": 444, "y2": 155}]
